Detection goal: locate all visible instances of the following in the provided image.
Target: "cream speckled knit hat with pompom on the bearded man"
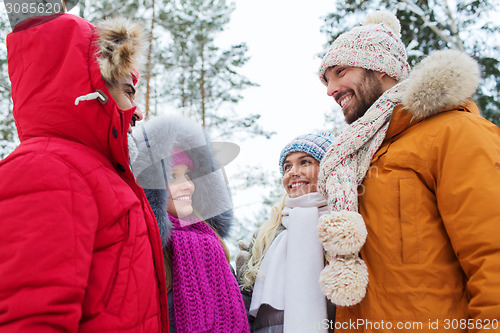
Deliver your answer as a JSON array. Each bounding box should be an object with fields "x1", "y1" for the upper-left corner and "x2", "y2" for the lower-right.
[{"x1": 319, "y1": 11, "x2": 410, "y2": 85}]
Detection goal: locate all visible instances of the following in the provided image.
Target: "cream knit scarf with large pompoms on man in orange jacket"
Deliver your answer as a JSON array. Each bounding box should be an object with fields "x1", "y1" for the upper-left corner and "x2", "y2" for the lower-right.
[{"x1": 318, "y1": 84, "x2": 402, "y2": 306}]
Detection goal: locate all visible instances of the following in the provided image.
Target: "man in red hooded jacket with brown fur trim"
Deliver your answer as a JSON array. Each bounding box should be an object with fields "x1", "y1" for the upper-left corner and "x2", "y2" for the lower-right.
[{"x1": 0, "y1": 14, "x2": 168, "y2": 332}]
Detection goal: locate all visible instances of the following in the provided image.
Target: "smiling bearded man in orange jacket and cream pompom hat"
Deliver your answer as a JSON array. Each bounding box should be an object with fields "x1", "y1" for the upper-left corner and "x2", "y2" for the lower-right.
[{"x1": 318, "y1": 12, "x2": 500, "y2": 332}]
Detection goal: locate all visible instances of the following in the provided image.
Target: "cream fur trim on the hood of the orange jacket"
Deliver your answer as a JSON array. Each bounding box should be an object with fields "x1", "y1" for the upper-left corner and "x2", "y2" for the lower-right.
[{"x1": 401, "y1": 50, "x2": 480, "y2": 121}]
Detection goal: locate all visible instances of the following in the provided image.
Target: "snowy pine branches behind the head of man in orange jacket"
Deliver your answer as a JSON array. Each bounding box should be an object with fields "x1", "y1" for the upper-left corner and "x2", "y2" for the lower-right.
[{"x1": 322, "y1": 0, "x2": 500, "y2": 125}]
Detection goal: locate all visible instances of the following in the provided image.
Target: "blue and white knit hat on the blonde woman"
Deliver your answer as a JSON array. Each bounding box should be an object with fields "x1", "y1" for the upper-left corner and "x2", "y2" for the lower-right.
[{"x1": 280, "y1": 132, "x2": 332, "y2": 176}]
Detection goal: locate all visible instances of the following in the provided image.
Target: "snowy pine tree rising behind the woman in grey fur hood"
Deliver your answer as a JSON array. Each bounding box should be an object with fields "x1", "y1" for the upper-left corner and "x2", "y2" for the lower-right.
[{"x1": 159, "y1": 0, "x2": 272, "y2": 138}]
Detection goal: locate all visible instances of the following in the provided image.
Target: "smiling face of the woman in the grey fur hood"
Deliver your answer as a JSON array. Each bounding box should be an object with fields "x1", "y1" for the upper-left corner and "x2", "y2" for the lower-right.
[{"x1": 167, "y1": 164, "x2": 194, "y2": 219}]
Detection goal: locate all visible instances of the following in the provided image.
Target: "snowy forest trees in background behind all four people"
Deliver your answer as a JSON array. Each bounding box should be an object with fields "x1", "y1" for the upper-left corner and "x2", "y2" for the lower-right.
[{"x1": 0, "y1": 0, "x2": 500, "y2": 259}]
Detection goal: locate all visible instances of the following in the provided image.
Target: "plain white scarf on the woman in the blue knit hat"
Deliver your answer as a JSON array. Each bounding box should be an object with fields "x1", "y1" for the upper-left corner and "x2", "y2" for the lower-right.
[{"x1": 250, "y1": 192, "x2": 327, "y2": 333}]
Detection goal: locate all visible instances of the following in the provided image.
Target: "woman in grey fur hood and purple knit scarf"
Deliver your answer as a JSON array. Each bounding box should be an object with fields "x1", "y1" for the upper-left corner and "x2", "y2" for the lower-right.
[{"x1": 132, "y1": 116, "x2": 249, "y2": 333}]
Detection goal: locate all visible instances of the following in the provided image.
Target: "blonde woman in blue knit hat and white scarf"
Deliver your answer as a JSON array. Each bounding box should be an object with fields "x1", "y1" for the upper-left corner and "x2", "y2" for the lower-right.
[{"x1": 237, "y1": 133, "x2": 333, "y2": 333}]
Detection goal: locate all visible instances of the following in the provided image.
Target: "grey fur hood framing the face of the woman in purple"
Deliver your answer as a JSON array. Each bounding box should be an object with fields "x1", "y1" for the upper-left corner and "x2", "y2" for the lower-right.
[{"x1": 132, "y1": 116, "x2": 233, "y2": 246}]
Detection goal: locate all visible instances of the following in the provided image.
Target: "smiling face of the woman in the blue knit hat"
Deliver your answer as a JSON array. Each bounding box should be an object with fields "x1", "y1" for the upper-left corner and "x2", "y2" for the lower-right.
[{"x1": 283, "y1": 151, "x2": 319, "y2": 198}]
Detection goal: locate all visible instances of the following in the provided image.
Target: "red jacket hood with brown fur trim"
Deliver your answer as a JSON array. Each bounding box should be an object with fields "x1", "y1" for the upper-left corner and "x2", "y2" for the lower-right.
[{"x1": 7, "y1": 14, "x2": 145, "y2": 170}]
